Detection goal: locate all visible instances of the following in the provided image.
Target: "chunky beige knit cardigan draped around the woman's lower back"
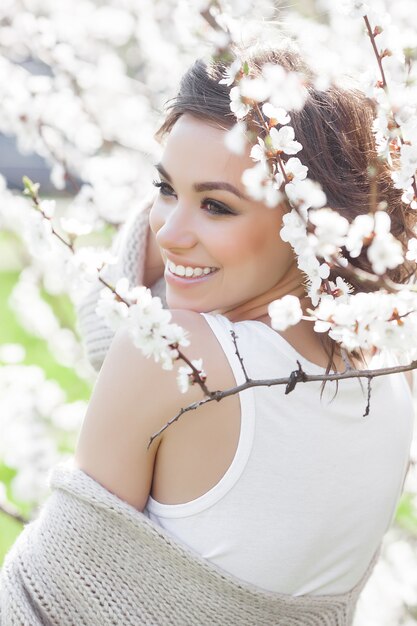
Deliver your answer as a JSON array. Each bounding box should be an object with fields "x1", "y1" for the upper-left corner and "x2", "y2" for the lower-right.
[{"x1": 0, "y1": 463, "x2": 380, "y2": 626}]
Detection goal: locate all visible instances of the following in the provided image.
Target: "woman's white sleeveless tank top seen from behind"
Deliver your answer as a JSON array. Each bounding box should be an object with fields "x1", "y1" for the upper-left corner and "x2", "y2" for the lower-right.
[{"x1": 144, "y1": 313, "x2": 414, "y2": 596}]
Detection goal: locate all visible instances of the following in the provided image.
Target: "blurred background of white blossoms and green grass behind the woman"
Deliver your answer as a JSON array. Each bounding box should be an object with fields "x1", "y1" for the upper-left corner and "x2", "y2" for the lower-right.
[{"x1": 0, "y1": 0, "x2": 417, "y2": 626}]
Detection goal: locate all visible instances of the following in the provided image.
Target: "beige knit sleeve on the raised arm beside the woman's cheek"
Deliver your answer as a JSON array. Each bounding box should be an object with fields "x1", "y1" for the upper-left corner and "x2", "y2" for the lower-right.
[{"x1": 77, "y1": 196, "x2": 166, "y2": 371}]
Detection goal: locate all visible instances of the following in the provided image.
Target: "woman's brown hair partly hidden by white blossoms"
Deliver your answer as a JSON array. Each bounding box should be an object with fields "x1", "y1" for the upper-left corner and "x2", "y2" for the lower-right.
[{"x1": 156, "y1": 49, "x2": 417, "y2": 370}]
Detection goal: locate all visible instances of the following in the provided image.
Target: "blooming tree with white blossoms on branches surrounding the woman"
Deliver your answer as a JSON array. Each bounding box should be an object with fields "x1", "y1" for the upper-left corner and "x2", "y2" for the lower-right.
[{"x1": 0, "y1": 0, "x2": 417, "y2": 624}]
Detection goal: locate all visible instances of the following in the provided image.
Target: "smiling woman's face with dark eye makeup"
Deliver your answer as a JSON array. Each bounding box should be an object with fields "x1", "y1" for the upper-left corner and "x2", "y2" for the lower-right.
[{"x1": 150, "y1": 114, "x2": 294, "y2": 312}]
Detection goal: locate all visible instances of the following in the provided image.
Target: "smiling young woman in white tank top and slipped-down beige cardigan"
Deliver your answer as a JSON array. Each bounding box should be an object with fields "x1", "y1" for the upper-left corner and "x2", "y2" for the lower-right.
[{"x1": 2, "y1": 45, "x2": 413, "y2": 626}]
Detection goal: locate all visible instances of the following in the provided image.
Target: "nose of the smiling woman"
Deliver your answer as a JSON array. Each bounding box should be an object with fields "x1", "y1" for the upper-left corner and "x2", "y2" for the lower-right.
[{"x1": 150, "y1": 202, "x2": 197, "y2": 250}]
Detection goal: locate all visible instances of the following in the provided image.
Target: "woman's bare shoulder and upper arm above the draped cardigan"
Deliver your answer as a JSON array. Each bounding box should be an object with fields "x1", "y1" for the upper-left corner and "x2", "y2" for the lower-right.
[{"x1": 75, "y1": 310, "x2": 234, "y2": 510}]
